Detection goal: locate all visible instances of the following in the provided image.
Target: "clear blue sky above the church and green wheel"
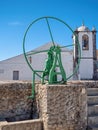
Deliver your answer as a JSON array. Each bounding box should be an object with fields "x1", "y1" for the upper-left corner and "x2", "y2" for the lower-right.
[{"x1": 0, "y1": 0, "x2": 98, "y2": 61}]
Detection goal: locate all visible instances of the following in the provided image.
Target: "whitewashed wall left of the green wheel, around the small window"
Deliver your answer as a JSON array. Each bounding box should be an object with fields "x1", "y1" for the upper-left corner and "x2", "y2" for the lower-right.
[{"x1": 0, "y1": 55, "x2": 32, "y2": 80}]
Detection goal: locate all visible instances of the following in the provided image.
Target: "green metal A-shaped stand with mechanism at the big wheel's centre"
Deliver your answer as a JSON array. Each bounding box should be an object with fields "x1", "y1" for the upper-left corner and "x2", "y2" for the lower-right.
[{"x1": 42, "y1": 45, "x2": 66, "y2": 84}]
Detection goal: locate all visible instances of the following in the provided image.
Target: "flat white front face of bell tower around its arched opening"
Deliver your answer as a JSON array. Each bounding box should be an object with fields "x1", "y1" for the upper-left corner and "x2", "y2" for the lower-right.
[{"x1": 79, "y1": 32, "x2": 94, "y2": 79}]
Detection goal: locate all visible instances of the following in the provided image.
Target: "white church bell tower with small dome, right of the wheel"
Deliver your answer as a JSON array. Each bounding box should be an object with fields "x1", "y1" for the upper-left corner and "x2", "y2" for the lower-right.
[{"x1": 73, "y1": 24, "x2": 96, "y2": 80}]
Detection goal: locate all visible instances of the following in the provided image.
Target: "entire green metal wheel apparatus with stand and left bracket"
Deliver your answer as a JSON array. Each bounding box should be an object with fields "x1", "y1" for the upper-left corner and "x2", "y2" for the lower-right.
[{"x1": 23, "y1": 16, "x2": 81, "y2": 98}]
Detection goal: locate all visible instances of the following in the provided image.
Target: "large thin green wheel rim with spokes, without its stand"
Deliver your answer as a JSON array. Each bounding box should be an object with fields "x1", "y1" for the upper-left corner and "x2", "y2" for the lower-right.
[{"x1": 23, "y1": 16, "x2": 81, "y2": 80}]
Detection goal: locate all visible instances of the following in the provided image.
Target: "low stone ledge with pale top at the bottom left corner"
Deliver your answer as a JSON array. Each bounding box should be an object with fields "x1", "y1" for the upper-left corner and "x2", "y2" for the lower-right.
[{"x1": 0, "y1": 119, "x2": 42, "y2": 130}]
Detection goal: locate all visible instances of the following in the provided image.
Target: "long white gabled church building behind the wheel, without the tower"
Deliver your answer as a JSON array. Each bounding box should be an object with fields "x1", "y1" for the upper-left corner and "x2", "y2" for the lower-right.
[{"x1": 0, "y1": 43, "x2": 73, "y2": 80}]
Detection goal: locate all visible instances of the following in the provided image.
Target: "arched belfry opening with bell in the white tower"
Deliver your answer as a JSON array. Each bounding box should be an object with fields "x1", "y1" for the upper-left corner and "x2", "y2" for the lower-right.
[{"x1": 82, "y1": 35, "x2": 89, "y2": 50}]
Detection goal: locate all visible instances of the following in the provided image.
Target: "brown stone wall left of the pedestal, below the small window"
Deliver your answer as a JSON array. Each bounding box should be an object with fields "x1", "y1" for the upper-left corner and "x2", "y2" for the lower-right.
[{"x1": 0, "y1": 81, "x2": 33, "y2": 121}]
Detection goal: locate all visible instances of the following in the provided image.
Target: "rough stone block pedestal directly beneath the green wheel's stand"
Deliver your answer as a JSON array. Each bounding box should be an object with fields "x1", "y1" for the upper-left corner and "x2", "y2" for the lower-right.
[{"x1": 36, "y1": 83, "x2": 87, "y2": 130}]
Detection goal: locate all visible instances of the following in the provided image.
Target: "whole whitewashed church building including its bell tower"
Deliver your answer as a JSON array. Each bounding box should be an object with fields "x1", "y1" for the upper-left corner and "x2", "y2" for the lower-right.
[{"x1": 0, "y1": 25, "x2": 96, "y2": 80}]
